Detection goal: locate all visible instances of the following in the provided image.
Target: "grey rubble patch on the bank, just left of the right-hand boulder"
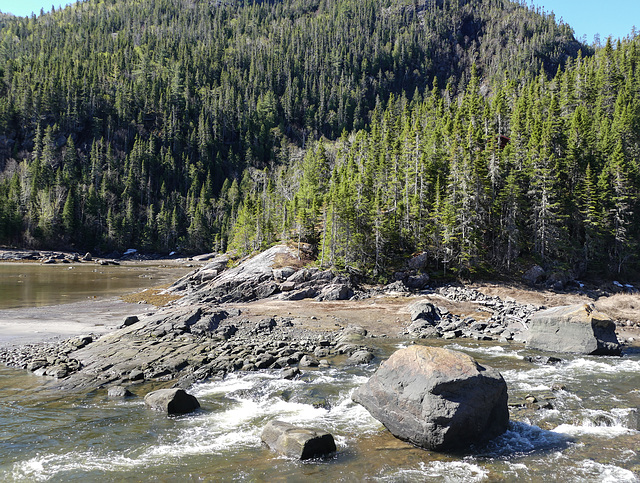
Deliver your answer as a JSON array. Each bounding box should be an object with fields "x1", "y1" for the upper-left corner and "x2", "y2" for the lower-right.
[{"x1": 406, "y1": 286, "x2": 540, "y2": 340}]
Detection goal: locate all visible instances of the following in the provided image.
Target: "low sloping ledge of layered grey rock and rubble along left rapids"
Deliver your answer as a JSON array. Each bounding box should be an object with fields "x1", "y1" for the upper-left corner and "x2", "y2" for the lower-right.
[{"x1": 0, "y1": 305, "x2": 373, "y2": 389}]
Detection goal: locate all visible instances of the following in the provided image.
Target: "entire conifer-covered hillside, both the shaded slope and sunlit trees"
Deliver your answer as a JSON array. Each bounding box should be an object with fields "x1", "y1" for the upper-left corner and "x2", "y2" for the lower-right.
[{"x1": 0, "y1": 0, "x2": 638, "y2": 282}]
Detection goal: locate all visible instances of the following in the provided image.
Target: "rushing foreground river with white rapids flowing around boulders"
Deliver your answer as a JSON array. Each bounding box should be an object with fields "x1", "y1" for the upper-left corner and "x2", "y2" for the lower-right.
[{"x1": 0, "y1": 266, "x2": 640, "y2": 482}]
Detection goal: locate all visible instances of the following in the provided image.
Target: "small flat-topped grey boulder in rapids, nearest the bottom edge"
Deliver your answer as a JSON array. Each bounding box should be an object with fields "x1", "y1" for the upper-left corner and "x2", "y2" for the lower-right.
[{"x1": 261, "y1": 421, "x2": 336, "y2": 460}]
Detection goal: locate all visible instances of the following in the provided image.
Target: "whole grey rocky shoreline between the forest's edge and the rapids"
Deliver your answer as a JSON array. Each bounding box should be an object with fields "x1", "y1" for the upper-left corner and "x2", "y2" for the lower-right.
[{"x1": 0, "y1": 246, "x2": 636, "y2": 396}]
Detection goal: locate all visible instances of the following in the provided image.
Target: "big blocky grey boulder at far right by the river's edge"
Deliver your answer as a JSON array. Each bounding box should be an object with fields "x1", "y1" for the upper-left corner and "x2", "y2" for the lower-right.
[{"x1": 527, "y1": 304, "x2": 621, "y2": 355}]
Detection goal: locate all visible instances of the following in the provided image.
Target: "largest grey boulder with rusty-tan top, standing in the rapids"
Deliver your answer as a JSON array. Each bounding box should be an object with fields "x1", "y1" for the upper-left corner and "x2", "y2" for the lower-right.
[{"x1": 352, "y1": 345, "x2": 509, "y2": 451}]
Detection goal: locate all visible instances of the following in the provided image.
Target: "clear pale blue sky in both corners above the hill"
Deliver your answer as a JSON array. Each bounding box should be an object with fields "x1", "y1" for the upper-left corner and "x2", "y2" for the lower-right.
[{"x1": 0, "y1": 0, "x2": 640, "y2": 44}]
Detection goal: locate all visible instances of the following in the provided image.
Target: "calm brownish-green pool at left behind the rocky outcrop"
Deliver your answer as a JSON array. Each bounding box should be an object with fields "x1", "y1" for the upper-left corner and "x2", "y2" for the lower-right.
[{"x1": 0, "y1": 263, "x2": 189, "y2": 309}]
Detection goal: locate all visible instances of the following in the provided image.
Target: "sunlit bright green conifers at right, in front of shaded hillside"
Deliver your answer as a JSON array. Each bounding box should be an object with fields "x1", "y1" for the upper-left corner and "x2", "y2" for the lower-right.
[{"x1": 232, "y1": 36, "x2": 640, "y2": 276}]
